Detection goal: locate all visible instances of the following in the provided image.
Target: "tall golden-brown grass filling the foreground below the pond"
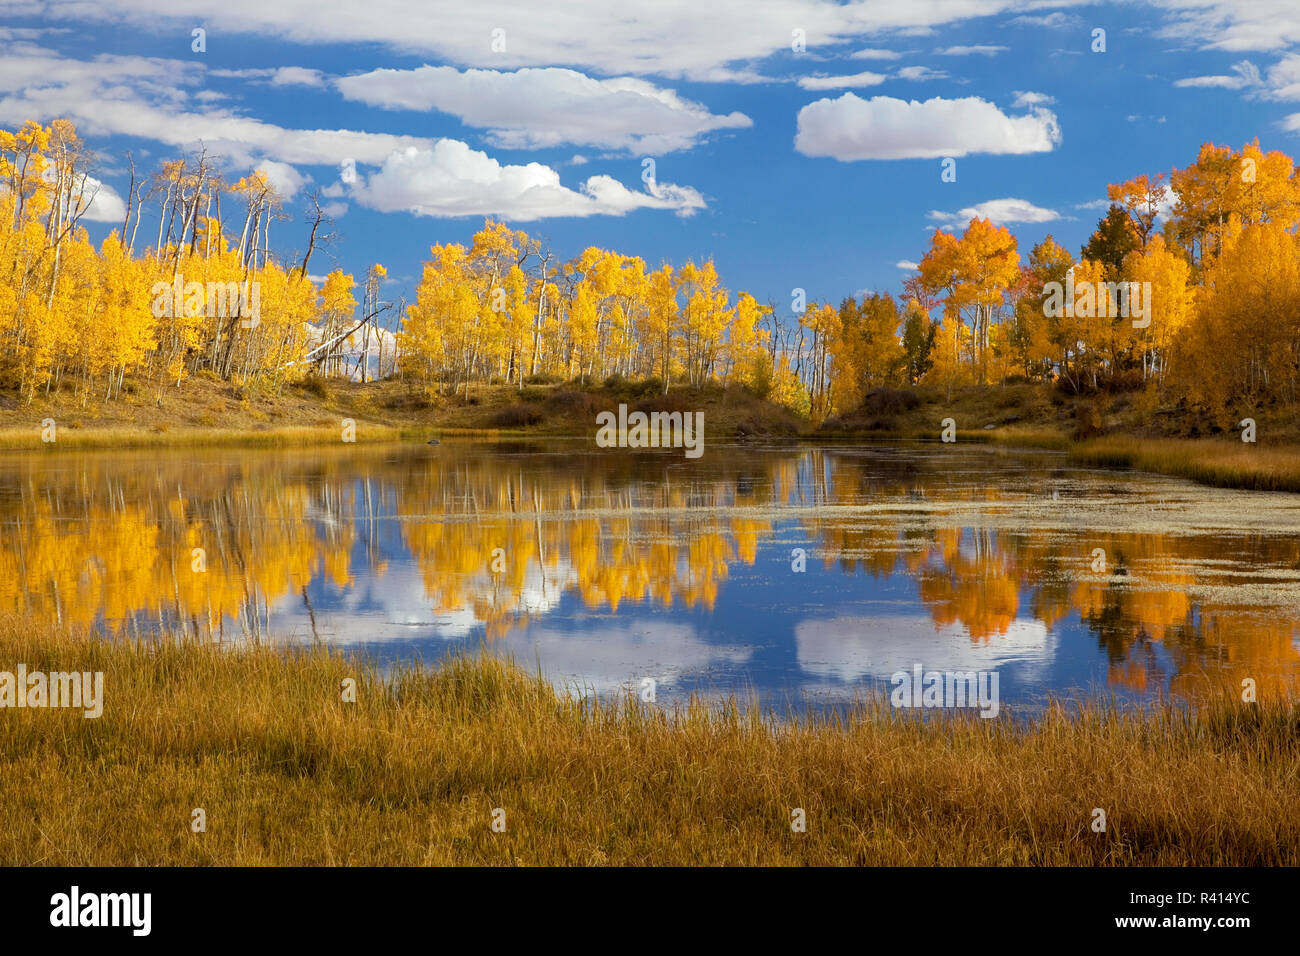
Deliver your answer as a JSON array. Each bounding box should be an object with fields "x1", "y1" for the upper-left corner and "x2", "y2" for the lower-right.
[{"x1": 0, "y1": 619, "x2": 1300, "y2": 865}]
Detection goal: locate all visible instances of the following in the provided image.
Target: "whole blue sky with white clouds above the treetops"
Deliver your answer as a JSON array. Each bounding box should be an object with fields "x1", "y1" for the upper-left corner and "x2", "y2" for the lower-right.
[{"x1": 0, "y1": 0, "x2": 1300, "y2": 321}]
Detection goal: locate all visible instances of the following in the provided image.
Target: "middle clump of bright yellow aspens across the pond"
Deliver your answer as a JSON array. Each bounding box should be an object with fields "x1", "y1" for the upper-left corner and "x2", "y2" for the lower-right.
[{"x1": 399, "y1": 220, "x2": 793, "y2": 403}]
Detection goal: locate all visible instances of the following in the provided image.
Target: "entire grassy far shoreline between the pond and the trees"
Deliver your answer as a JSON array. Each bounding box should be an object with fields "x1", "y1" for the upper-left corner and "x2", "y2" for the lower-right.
[{"x1": 0, "y1": 380, "x2": 1300, "y2": 492}]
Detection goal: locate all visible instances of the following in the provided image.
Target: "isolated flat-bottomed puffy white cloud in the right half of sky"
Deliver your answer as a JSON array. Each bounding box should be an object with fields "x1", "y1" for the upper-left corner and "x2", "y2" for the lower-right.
[{"x1": 794, "y1": 92, "x2": 1061, "y2": 161}]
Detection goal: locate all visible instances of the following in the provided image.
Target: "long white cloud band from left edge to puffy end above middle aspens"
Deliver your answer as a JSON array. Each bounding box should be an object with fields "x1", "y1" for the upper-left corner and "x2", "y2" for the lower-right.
[{"x1": 0, "y1": 47, "x2": 702, "y2": 221}]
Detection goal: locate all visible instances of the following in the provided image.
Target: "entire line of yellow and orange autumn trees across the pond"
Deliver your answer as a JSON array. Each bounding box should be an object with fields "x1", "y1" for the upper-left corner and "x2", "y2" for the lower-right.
[{"x1": 0, "y1": 120, "x2": 1300, "y2": 421}]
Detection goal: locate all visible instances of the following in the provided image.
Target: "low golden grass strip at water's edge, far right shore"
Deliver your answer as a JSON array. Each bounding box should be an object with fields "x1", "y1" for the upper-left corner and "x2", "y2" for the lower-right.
[{"x1": 1070, "y1": 437, "x2": 1300, "y2": 492}]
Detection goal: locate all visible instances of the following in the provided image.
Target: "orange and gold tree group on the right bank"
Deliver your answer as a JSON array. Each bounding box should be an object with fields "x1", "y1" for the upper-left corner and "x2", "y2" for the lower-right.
[{"x1": 905, "y1": 142, "x2": 1300, "y2": 411}]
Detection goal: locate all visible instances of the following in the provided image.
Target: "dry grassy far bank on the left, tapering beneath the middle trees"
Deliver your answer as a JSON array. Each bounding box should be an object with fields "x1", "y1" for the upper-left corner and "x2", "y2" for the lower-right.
[{"x1": 0, "y1": 376, "x2": 807, "y2": 451}]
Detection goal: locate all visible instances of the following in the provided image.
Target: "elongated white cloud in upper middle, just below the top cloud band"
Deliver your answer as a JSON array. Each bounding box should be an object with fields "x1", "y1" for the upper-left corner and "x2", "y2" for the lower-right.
[{"x1": 334, "y1": 65, "x2": 753, "y2": 155}]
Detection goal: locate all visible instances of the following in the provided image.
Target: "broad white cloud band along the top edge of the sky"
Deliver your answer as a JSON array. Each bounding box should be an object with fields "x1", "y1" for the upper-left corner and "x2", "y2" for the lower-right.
[{"x1": 27, "y1": 0, "x2": 1086, "y2": 81}]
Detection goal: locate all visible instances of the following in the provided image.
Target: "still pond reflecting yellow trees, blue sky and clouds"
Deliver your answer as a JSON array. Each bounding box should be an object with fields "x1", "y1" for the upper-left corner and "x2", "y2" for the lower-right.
[{"x1": 0, "y1": 440, "x2": 1300, "y2": 709}]
